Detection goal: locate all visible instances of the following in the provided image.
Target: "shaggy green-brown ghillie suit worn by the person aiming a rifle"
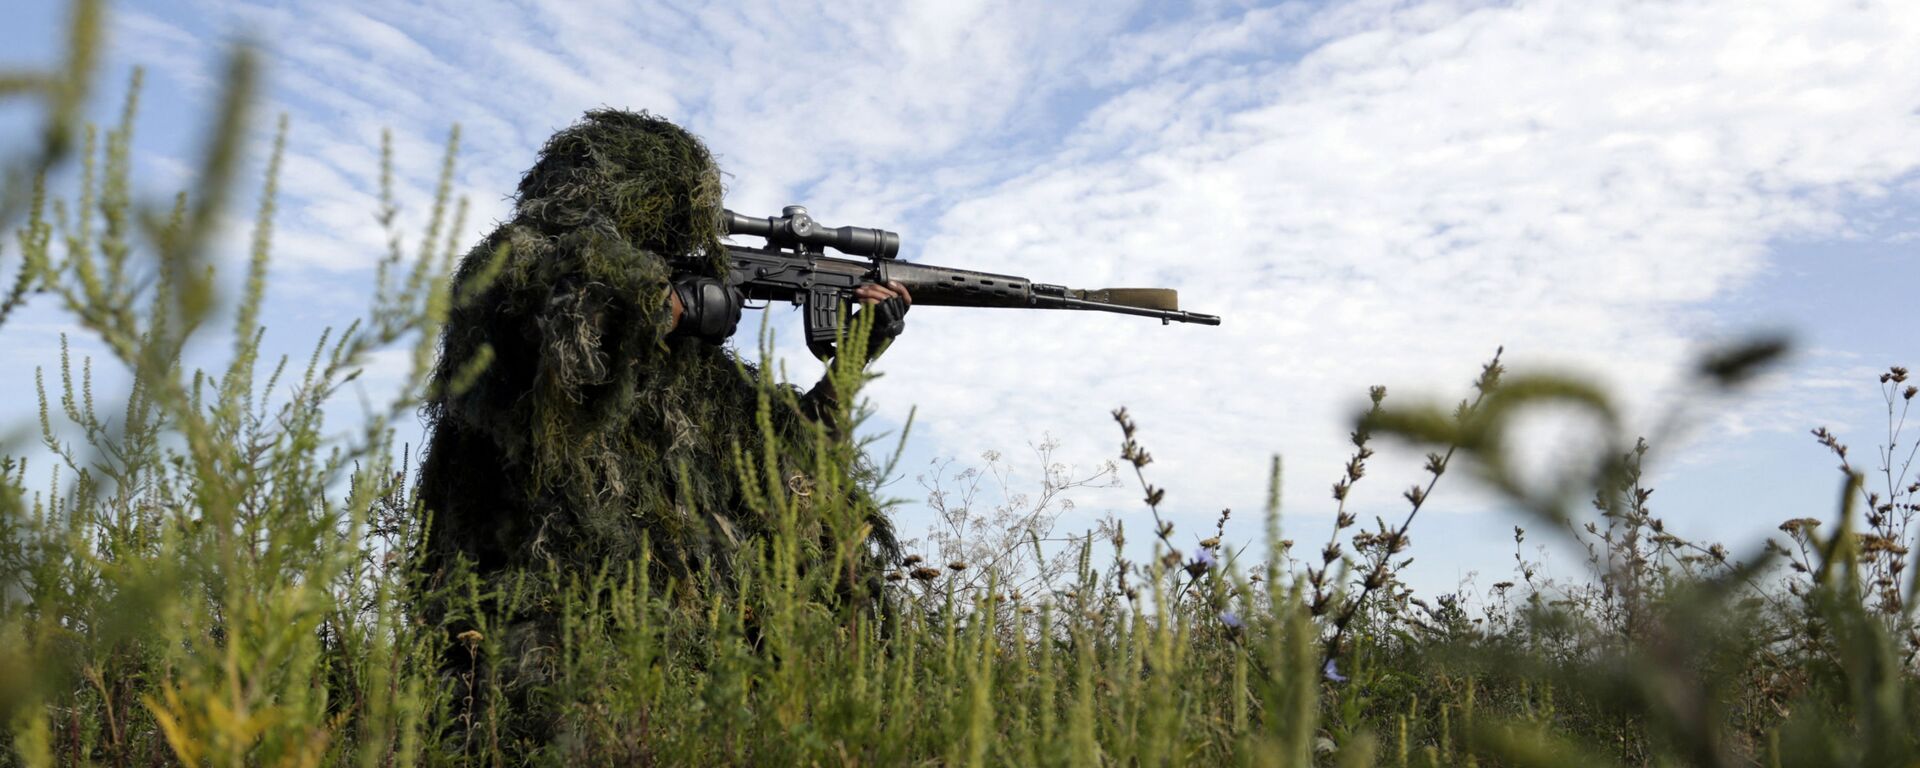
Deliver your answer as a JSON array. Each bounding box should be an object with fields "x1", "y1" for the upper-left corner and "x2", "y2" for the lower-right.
[{"x1": 420, "y1": 109, "x2": 897, "y2": 748}]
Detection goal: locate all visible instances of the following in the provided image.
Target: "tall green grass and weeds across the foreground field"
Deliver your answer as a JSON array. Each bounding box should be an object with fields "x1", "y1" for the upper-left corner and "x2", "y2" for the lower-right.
[{"x1": 0, "y1": 2, "x2": 1920, "y2": 766}]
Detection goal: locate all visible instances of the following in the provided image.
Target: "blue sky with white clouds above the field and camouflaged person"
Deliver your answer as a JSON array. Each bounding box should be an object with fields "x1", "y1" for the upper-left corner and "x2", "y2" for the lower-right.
[{"x1": 0, "y1": 0, "x2": 1920, "y2": 591}]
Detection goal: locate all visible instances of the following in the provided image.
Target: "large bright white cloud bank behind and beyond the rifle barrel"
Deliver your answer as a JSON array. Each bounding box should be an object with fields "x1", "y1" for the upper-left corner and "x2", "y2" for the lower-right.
[{"x1": 876, "y1": 2, "x2": 1920, "y2": 533}]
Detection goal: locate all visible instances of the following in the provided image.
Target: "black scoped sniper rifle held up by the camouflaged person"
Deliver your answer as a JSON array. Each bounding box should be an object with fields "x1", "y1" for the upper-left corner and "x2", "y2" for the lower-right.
[{"x1": 722, "y1": 205, "x2": 1219, "y2": 359}]
